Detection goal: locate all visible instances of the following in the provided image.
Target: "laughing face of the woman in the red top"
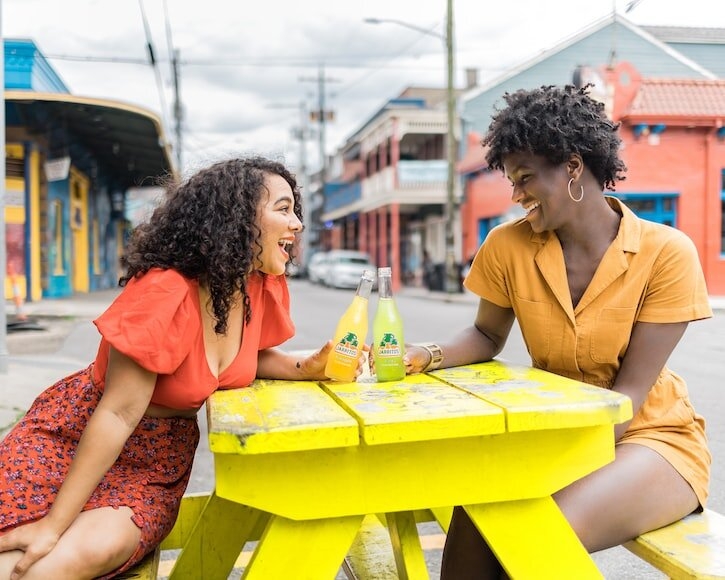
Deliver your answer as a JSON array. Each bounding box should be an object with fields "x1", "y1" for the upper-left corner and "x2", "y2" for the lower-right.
[{"x1": 255, "y1": 175, "x2": 302, "y2": 275}]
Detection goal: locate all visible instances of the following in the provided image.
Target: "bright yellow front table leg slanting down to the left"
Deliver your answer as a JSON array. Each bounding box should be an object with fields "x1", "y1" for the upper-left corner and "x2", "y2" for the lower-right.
[{"x1": 242, "y1": 515, "x2": 363, "y2": 580}]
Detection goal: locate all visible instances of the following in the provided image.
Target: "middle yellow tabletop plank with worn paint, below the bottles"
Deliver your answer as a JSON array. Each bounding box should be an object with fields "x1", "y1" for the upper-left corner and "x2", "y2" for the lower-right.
[{"x1": 322, "y1": 375, "x2": 505, "y2": 445}]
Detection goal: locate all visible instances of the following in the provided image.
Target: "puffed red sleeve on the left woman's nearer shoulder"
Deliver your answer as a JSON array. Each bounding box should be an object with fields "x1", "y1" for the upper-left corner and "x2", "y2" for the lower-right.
[{"x1": 93, "y1": 269, "x2": 201, "y2": 374}]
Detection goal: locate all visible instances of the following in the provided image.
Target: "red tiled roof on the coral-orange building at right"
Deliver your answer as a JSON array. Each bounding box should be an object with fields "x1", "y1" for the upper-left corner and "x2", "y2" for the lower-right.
[{"x1": 625, "y1": 79, "x2": 725, "y2": 124}]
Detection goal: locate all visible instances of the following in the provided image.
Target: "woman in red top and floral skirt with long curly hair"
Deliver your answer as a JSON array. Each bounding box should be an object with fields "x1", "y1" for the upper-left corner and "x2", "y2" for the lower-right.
[{"x1": 0, "y1": 158, "x2": 346, "y2": 580}]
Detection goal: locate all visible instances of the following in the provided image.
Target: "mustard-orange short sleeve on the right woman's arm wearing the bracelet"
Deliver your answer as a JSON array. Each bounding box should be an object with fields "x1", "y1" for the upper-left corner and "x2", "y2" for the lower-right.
[{"x1": 464, "y1": 224, "x2": 511, "y2": 308}]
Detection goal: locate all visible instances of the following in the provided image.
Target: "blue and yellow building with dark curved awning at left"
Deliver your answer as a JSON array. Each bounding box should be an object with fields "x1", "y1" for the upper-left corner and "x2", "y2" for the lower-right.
[{"x1": 4, "y1": 39, "x2": 174, "y2": 301}]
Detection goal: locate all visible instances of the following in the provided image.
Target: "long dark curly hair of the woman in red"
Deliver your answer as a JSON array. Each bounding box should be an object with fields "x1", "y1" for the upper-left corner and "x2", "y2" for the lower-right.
[{"x1": 119, "y1": 157, "x2": 302, "y2": 334}]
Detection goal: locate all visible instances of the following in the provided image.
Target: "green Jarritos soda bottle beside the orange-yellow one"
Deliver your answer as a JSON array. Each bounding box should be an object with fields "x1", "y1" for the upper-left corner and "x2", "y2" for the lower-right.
[{"x1": 373, "y1": 268, "x2": 405, "y2": 382}]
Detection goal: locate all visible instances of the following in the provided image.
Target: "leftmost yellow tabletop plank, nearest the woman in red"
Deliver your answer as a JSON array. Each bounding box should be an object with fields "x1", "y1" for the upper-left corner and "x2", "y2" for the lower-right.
[{"x1": 207, "y1": 380, "x2": 360, "y2": 455}]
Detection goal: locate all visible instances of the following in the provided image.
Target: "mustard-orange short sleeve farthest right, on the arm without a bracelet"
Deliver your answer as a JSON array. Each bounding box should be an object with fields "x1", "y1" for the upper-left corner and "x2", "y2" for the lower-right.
[{"x1": 637, "y1": 229, "x2": 712, "y2": 323}]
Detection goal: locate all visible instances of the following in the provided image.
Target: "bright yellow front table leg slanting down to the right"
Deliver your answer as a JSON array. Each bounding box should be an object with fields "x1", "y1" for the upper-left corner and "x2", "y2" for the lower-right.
[{"x1": 464, "y1": 497, "x2": 602, "y2": 580}]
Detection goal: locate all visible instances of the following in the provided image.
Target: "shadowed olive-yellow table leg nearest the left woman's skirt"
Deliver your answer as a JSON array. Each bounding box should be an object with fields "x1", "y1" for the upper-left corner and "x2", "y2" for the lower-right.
[{"x1": 169, "y1": 493, "x2": 269, "y2": 580}]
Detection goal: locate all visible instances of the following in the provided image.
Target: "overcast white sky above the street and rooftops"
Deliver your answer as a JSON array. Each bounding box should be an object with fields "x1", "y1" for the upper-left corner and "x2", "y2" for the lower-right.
[{"x1": 0, "y1": 0, "x2": 725, "y2": 173}]
